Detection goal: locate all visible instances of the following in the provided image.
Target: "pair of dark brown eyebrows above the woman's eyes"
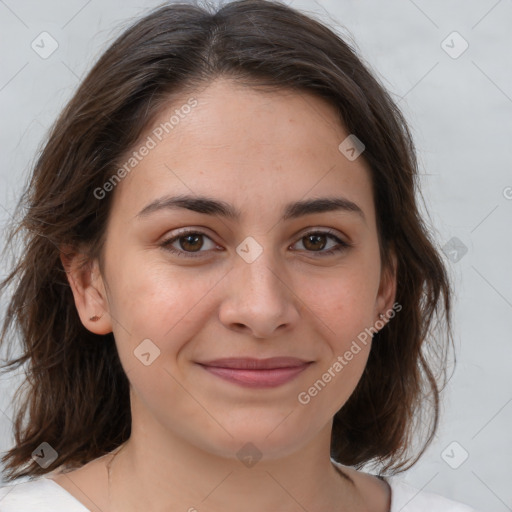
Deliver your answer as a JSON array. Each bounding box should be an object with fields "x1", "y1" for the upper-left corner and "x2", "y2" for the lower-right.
[{"x1": 136, "y1": 195, "x2": 366, "y2": 223}]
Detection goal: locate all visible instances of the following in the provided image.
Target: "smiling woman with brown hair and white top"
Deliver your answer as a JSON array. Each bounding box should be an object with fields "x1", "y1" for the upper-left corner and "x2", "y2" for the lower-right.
[{"x1": 0, "y1": 0, "x2": 480, "y2": 512}]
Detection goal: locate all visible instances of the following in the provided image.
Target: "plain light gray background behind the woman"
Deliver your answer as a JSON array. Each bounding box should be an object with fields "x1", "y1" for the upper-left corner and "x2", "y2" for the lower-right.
[{"x1": 0, "y1": 0, "x2": 512, "y2": 512}]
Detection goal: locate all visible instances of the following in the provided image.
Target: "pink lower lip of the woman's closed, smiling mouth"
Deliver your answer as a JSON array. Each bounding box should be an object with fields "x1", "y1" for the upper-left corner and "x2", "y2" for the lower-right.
[{"x1": 201, "y1": 363, "x2": 310, "y2": 388}]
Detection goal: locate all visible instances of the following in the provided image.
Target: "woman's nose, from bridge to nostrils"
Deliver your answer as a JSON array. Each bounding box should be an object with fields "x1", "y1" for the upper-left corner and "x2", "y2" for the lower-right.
[{"x1": 219, "y1": 250, "x2": 301, "y2": 339}]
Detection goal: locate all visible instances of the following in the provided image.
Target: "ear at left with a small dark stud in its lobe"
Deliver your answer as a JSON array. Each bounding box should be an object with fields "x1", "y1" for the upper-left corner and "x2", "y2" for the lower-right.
[{"x1": 60, "y1": 246, "x2": 112, "y2": 334}]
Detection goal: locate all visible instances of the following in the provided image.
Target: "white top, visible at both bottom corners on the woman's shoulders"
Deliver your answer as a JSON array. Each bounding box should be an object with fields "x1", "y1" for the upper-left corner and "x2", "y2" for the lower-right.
[{"x1": 0, "y1": 476, "x2": 477, "y2": 512}]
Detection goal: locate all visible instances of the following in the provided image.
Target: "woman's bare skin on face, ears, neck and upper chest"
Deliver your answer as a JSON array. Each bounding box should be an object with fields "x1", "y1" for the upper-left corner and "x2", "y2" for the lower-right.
[{"x1": 58, "y1": 79, "x2": 396, "y2": 512}]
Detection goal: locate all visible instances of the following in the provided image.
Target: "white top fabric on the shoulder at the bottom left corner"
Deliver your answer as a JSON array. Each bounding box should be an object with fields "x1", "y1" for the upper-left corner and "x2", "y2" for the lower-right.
[{"x1": 0, "y1": 477, "x2": 88, "y2": 512}]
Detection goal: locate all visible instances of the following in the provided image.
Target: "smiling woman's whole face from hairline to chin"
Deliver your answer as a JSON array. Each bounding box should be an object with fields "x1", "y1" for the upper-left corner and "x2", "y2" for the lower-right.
[{"x1": 67, "y1": 80, "x2": 394, "y2": 458}]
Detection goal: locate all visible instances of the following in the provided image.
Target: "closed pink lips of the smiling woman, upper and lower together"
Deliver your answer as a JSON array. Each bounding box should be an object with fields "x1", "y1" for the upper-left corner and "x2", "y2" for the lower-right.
[{"x1": 198, "y1": 357, "x2": 312, "y2": 388}]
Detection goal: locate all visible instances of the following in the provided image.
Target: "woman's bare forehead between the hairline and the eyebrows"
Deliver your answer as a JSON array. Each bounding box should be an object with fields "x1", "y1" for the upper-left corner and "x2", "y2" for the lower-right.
[{"x1": 108, "y1": 79, "x2": 374, "y2": 226}]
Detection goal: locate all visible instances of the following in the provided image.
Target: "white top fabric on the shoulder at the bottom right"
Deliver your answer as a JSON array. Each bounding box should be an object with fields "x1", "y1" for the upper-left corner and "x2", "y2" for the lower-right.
[{"x1": 385, "y1": 477, "x2": 477, "y2": 512}]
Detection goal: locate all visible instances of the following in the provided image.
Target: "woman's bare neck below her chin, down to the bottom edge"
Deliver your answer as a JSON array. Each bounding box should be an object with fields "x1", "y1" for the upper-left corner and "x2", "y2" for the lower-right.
[{"x1": 107, "y1": 436, "x2": 363, "y2": 512}]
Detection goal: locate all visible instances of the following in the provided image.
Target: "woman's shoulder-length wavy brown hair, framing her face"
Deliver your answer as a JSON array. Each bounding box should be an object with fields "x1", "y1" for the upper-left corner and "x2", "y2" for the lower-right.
[{"x1": 0, "y1": 0, "x2": 453, "y2": 480}]
